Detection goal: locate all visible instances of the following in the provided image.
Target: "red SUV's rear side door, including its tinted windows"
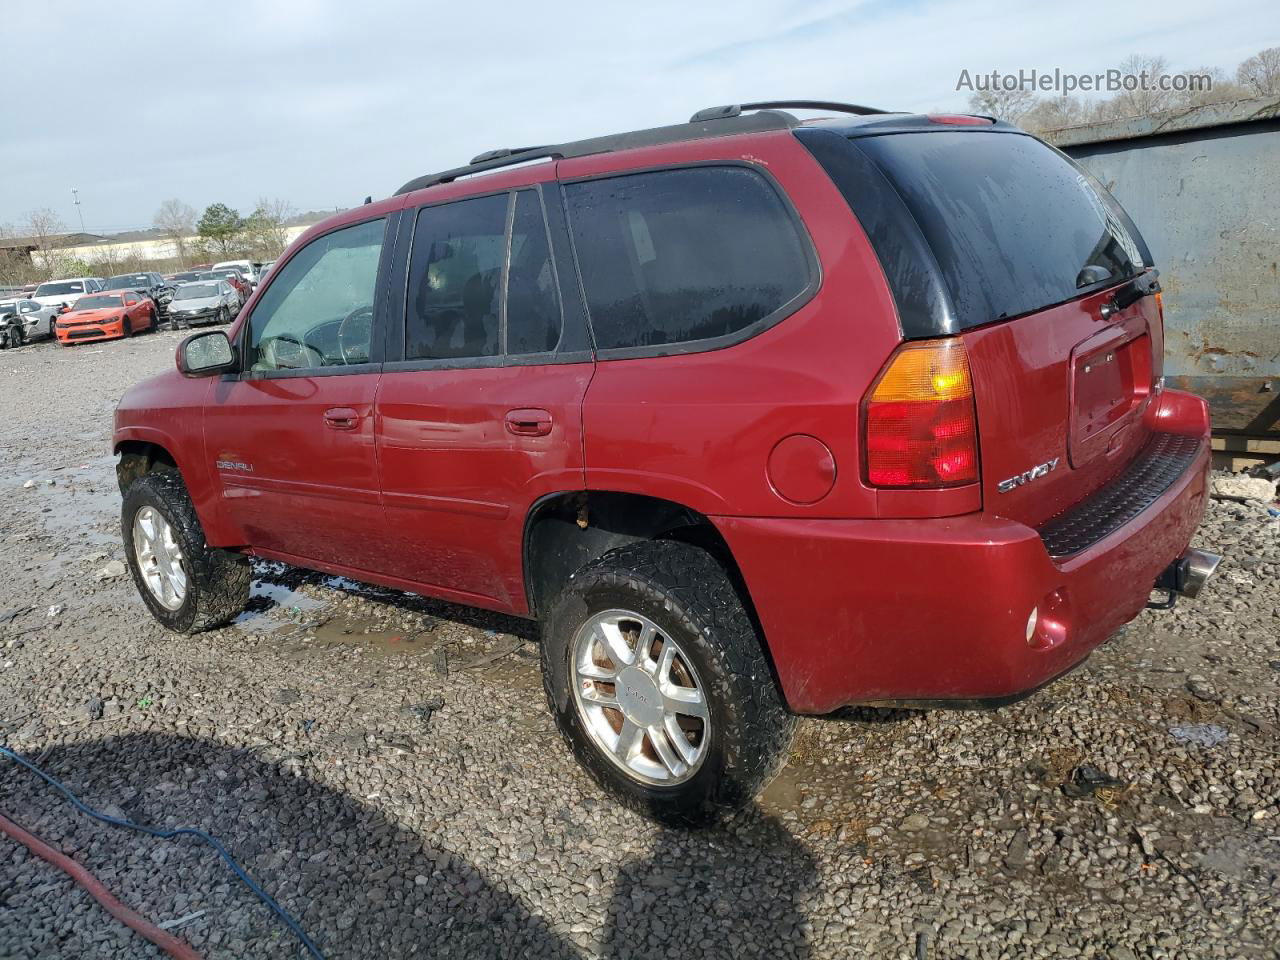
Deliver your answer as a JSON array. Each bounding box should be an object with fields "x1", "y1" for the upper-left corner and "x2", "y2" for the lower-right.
[{"x1": 376, "y1": 182, "x2": 594, "y2": 612}]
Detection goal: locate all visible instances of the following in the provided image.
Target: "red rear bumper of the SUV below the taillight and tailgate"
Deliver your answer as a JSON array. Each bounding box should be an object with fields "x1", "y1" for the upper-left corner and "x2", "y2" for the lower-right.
[{"x1": 716, "y1": 390, "x2": 1210, "y2": 713}]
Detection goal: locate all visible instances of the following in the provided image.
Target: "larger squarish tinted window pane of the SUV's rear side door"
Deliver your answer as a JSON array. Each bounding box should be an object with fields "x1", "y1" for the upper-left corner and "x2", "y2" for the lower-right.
[{"x1": 404, "y1": 193, "x2": 509, "y2": 360}]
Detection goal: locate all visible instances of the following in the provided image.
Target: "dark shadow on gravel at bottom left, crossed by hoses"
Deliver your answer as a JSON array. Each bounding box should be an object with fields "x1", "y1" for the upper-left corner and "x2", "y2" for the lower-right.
[{"x1": 0, "y1": 733, "x2": 815, "y2": 960}]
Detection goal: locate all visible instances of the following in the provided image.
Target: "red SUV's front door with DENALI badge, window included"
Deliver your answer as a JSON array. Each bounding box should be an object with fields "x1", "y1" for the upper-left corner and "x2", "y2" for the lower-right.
[{"x1": 205, "y1": 215, "x2": 396, "y2": 570}]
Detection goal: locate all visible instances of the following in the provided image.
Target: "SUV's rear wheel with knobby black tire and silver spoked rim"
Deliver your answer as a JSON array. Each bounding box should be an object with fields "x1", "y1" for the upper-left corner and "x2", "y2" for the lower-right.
[{"x1": 541, "y1": 540, "x2": 796, "y2": 824}]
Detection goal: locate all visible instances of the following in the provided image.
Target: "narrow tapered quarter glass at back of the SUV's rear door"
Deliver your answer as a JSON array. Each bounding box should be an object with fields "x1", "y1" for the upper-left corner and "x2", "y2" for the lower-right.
[{"x1": 507, "y1": 189, "x2": 563, "y2": 355}]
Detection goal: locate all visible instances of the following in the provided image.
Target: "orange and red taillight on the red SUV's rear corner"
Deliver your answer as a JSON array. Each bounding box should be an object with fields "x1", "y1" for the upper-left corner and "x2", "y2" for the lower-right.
[{"x1": 863, "y1": 339, "x2": 978, "y2": 488}]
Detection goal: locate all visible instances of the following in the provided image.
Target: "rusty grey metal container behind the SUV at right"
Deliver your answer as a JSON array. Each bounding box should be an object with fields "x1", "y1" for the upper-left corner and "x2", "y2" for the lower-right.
[{"x1": 1044, "y1": 97, "x2": 1280, "y2": 439}]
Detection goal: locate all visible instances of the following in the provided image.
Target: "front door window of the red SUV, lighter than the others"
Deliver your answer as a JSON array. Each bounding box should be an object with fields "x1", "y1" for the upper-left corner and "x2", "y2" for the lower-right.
[{"x1": 247, "y1": 220, "x2": 387, "y2": 372}]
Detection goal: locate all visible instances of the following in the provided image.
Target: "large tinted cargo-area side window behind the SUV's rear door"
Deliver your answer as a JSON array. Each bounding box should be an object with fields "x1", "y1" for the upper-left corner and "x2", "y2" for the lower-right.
[{"x1": 564, "y1": 166, "x2": 812, "y2": 349}]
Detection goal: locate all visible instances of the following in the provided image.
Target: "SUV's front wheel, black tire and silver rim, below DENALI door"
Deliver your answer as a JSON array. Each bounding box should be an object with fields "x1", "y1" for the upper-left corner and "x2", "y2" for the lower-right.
[{"x1": 120, "y1": 471, "x2": 251, "y2": 634}]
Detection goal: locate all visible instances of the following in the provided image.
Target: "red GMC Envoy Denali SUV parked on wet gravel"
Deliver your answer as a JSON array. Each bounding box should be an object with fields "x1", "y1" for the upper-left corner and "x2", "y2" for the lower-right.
[{"x1": 115, "y1": 102, "x2": 1216, "y2": 819}]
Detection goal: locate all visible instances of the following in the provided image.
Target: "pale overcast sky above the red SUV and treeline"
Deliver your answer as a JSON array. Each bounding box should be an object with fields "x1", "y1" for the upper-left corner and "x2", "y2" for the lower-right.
[{"x1": 0, "y1": 0, "x2": 1280, "y2": 233}]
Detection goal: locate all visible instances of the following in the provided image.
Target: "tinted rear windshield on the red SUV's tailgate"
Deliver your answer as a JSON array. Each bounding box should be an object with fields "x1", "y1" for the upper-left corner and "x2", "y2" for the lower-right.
[{"x1": 855, "y1": 132, "x2": 1143, "y2": 329}]
